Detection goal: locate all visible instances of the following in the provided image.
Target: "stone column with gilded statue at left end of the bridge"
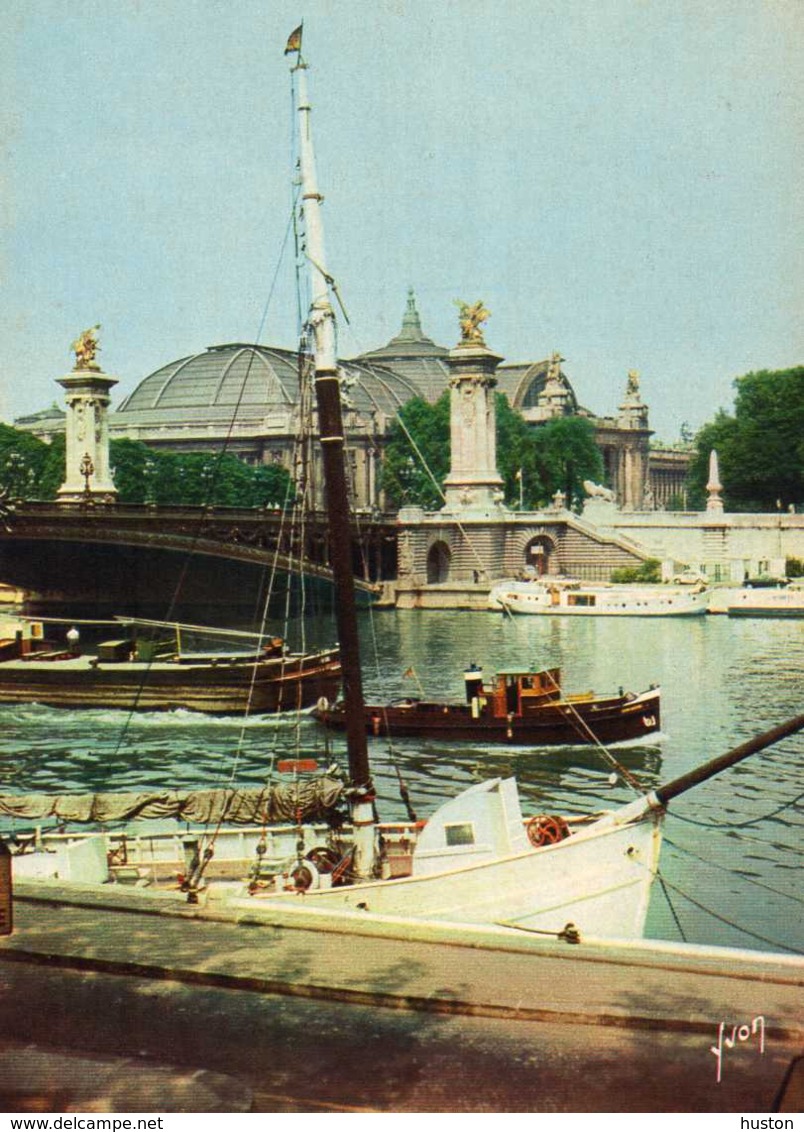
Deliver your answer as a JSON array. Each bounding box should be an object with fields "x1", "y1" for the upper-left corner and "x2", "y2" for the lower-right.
[{"x1": 58, "y1": 326, "x2": 118, "y2": 503}]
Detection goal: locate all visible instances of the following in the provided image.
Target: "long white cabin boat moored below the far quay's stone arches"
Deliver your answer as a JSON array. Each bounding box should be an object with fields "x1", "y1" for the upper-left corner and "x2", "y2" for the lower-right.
[{"x1": 488, "y1": 578, "x2": 709, "y2": 617}]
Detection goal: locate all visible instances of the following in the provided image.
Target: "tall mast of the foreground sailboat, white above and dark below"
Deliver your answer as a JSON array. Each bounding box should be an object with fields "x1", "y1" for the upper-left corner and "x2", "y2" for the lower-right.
[{"x1": 293, "y1": 35, "x2": 374, "y2": 876}]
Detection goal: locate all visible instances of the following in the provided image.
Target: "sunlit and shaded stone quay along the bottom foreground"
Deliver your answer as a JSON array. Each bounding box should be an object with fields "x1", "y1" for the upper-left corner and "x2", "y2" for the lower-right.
[{"x1": 0, "y1": 893, "x2": 804, "y2": 1113}]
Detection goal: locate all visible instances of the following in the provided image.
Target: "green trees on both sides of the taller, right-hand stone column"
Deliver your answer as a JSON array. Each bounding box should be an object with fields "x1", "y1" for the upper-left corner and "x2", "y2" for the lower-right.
[{"x1": 382, "y1": 392, "x2": 602, "y2": 511}]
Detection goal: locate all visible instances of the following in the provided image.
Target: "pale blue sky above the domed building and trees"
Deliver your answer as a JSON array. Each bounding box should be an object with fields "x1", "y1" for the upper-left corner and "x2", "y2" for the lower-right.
[{"x1": 0, "y1": 0, "x2": 804, "y2": 441}]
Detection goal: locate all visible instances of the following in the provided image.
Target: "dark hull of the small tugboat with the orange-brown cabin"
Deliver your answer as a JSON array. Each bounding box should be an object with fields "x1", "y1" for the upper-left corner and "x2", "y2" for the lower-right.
[{"x1": 313, "y1": 688, "x2": 661, "y2": 747}]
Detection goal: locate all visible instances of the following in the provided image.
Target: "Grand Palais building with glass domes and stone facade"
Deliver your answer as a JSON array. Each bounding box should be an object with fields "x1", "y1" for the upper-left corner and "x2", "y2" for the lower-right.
[{"x1": 15, "y1": 291, "x2": 690, "y2": 511}]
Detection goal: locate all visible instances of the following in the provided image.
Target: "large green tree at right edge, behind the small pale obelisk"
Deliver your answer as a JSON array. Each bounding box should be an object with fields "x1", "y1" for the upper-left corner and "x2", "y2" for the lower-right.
[{"x1": 688, "y1": 366, "x2": 804, "y2": 511}]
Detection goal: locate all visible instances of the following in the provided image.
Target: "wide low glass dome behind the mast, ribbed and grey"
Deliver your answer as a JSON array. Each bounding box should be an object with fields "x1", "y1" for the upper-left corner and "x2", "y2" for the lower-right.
[{"x1": 117, "y1": 343, "x2": 418, "y2": 420}]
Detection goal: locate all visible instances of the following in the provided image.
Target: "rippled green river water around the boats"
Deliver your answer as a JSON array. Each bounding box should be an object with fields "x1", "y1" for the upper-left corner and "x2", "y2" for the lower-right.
[{"x1": 0, "y1": 611, "x2": 804, "y2": 953}]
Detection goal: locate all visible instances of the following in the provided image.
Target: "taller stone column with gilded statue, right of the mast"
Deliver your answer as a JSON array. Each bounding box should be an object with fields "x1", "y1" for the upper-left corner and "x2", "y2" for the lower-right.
[{"x1": 444, "y1": 302, "x2": 503, "y2": 512}]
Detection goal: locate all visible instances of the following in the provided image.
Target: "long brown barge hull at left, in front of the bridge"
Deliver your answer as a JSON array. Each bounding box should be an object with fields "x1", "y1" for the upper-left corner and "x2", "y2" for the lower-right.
[{"x1": 0, "y1": 650, "x2": 341, "y2": 714}]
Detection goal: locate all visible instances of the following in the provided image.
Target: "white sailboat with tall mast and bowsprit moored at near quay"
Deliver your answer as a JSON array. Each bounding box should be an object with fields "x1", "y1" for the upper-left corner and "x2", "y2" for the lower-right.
[{"x1": 0, "y1": 36, "x2": 804, "y2": 943}]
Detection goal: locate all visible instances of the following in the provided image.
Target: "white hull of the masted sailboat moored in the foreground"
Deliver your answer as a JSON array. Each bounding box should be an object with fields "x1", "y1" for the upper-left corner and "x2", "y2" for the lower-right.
[{"x1": 6, "y1": 813, "x2": 661, "y2": 940}]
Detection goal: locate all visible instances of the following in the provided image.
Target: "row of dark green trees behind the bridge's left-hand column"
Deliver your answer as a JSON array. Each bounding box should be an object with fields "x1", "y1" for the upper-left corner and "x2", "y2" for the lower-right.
[{"x1": 0, "y1": 425, "x2": 296, "y2": 507}]
